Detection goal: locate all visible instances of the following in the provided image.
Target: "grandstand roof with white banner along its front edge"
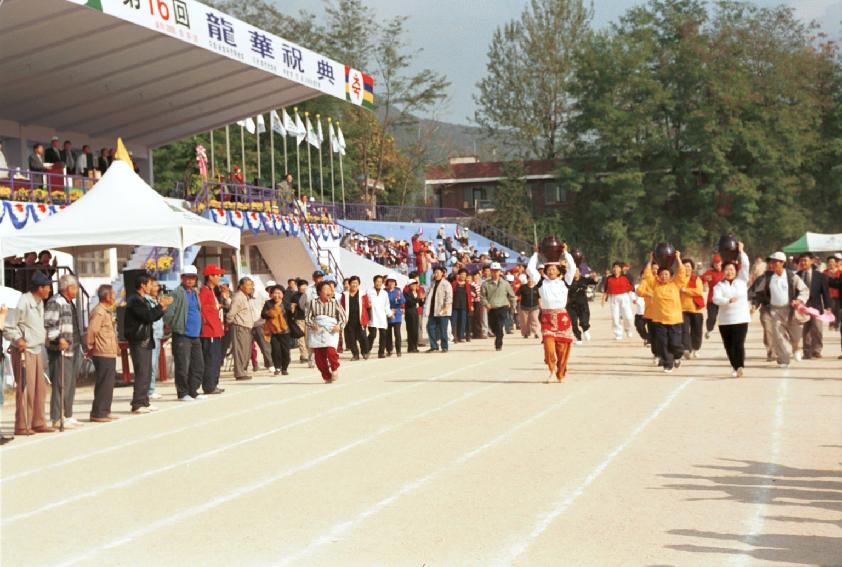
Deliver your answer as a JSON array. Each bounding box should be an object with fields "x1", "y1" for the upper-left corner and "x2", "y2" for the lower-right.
[{"x1": 0, "y1": 0, "x2": 373, "y2": 148}]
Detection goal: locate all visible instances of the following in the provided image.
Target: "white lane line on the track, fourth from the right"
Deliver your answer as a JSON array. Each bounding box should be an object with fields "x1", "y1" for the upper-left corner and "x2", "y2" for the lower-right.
[{"x1": 57, "y1": 355, "x2": 520, "y2": 567}]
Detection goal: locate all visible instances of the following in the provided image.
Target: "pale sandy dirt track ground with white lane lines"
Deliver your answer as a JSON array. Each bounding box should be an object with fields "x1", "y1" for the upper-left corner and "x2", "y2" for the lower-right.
[{"x1": 0, "y1": 305, "x2": 842, "y2": 567}]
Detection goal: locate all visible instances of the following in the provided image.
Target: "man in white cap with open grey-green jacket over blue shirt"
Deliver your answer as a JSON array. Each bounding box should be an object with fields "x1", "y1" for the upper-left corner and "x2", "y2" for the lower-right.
[{"x1": 164, "y1": 266, "x2": 205, "y2": 402}]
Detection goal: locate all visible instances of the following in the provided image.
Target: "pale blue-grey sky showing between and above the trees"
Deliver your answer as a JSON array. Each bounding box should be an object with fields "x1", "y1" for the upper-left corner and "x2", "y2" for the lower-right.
[{"x1": 275, "y1": 0, "x2": 842, "y2": 124}]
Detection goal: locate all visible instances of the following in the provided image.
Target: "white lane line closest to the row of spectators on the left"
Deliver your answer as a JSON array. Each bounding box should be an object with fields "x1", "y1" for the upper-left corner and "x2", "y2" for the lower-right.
[{"x1": 0, "y1": 358, "x2": 440, "y2": 484}]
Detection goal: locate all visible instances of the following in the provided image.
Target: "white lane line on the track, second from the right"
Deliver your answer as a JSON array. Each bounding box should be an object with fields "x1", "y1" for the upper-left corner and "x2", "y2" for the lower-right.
[{"x1": 496, "y1": 378, "x2": 693, "y2": 565}]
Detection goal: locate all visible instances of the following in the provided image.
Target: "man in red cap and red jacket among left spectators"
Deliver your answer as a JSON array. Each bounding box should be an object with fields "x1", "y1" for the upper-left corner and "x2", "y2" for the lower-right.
[{"x1": 199, "y1": 264, "x2": 225, "y2": 394}]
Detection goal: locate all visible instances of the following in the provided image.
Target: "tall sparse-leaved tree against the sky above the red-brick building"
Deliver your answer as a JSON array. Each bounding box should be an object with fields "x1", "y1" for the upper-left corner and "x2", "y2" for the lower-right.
[{"x1": 474, "y1": 0, "x2": 593, "y2": 159}]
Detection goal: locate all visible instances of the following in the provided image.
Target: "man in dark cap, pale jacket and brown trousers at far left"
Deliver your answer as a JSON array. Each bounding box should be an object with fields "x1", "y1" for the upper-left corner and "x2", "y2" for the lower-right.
[{"x1": 3, "y1": 273, "x2": 55, "y2": 435}]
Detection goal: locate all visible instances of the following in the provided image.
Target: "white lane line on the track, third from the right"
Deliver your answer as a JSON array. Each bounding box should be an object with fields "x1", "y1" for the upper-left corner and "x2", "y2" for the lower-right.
[{"x1": 277, "y1": 385, "x2": 589, "y2": 566}]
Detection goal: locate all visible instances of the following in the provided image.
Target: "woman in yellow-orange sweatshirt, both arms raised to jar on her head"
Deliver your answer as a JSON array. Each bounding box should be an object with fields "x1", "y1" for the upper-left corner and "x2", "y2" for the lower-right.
[{"x1": 643, "y1": 250, "x2": 690, "y2": 374}]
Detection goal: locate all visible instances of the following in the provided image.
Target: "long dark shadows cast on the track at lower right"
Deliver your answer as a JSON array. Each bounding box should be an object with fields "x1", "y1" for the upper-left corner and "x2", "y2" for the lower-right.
[{"x1": 658, "y1": 459, "x2": 842, "y2": 566}]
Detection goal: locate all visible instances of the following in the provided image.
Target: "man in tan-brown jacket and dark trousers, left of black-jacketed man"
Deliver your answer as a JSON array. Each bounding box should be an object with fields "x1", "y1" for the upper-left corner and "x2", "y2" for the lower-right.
[{"x1": 85, "y1": 284, "x2": 118, "y2": 423}]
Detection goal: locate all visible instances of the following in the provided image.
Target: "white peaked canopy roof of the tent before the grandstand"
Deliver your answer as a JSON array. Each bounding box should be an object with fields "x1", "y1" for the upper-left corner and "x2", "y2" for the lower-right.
[{"x1": 0, "y1": 160, "x2": 241, "y2": 257}]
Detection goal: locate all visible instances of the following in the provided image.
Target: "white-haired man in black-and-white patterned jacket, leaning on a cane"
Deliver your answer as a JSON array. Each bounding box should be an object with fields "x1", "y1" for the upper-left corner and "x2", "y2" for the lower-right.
[{"x1": 44, "y1": 274, "x2": 84, "y2": 428}]
